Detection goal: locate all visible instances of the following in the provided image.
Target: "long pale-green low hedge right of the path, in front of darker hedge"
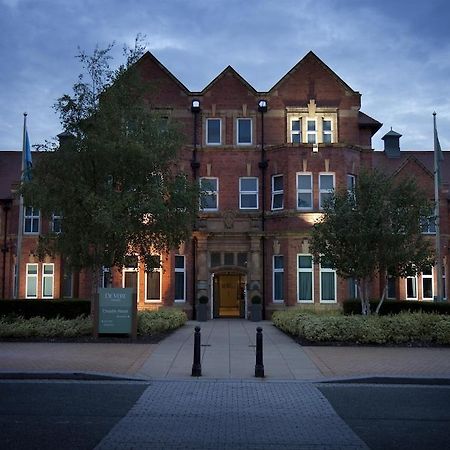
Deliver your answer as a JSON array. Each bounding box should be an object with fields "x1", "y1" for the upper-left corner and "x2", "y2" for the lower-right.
[{"x1": 272, "y1": 308, "x2": 450, "y2": 345}]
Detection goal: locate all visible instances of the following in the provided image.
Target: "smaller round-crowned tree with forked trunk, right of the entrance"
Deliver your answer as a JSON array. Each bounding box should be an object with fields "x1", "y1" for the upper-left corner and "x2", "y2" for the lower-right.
[{"x1": 312, "y1": 170, "x2": 434, "y2": 315}]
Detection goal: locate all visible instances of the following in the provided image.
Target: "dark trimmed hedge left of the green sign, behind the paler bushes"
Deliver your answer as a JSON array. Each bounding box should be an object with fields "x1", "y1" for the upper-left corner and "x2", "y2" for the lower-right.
[{"x1": 0, "y1": 299, "x2": 91, "y2": 319}]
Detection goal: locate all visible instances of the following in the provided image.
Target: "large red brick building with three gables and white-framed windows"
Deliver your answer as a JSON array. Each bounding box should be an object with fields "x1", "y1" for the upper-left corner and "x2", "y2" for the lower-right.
[{"x1": 0, "y1": 52, "x2": 450, "y2": 317}]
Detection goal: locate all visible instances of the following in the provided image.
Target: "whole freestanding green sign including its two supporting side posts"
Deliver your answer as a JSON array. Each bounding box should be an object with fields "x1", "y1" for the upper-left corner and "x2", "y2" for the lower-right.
[{"x1": 94, "y1": 288, "x2": 137, "y2": 339}]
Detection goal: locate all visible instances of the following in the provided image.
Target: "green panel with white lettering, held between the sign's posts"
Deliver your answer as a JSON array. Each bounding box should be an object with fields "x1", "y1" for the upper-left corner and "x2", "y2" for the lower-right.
[{"x1": 98, "y1": 288, "x2": 133, "y2": 334}]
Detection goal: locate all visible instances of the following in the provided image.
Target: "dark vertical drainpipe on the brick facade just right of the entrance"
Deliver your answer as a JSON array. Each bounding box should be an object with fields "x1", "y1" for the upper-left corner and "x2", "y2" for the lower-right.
[{"x1": 258, "y1": 100, "x2": 268, "y2": 320}]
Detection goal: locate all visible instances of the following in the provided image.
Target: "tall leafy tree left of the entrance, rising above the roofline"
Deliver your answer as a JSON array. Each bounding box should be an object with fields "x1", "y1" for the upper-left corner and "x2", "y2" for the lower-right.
[{"x1": 21, "y1": 37, "x2": 198, "y2": 296}]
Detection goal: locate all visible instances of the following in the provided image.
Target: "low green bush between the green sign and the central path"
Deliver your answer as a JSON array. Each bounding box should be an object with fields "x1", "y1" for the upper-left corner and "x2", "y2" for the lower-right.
[{"x1": 138, "y1": 308, "x2": 187, "y2": 336}]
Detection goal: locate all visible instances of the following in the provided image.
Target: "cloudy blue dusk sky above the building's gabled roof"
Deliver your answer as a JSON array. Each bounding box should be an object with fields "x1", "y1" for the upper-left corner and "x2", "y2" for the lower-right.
[{"x1": 0, "y1": 0, "x2": 450, "y2": 150}]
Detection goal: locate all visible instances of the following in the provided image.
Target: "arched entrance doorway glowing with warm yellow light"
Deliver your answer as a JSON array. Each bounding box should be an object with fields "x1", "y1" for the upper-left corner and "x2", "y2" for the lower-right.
[{"x1": 213, "y1": 272, "x2": 246, "y2": 318}]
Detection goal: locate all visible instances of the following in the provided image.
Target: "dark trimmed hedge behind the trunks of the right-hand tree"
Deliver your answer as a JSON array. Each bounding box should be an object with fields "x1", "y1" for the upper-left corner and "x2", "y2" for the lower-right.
[{"x1": 342, "y1": 299, "x2": 450, "y2": 316}]
